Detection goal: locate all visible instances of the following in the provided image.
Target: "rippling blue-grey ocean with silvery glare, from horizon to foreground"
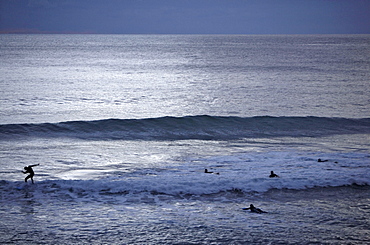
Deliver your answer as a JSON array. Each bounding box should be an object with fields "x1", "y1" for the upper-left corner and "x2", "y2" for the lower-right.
[{"x1": 0, "y1": 34, "x2": 370, "y2": 244}]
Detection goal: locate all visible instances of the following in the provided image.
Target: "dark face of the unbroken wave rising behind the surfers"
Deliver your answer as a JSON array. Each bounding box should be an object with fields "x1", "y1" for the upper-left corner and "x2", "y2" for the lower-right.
[{"x1": 0, "y1": 115, "x2": 370, "y2": 140}]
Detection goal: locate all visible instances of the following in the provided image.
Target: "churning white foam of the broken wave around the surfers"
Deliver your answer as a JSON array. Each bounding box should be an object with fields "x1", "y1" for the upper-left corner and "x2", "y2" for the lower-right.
[{"x1": 2, "y1": 152, "x2": 370, "y2": 205}]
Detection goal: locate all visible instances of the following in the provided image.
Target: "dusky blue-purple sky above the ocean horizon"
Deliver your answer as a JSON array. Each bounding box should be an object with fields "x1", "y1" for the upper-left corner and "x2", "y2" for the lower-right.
[{"x1": 0, "y1": 0, "x2": 370, "y2": 34}]
